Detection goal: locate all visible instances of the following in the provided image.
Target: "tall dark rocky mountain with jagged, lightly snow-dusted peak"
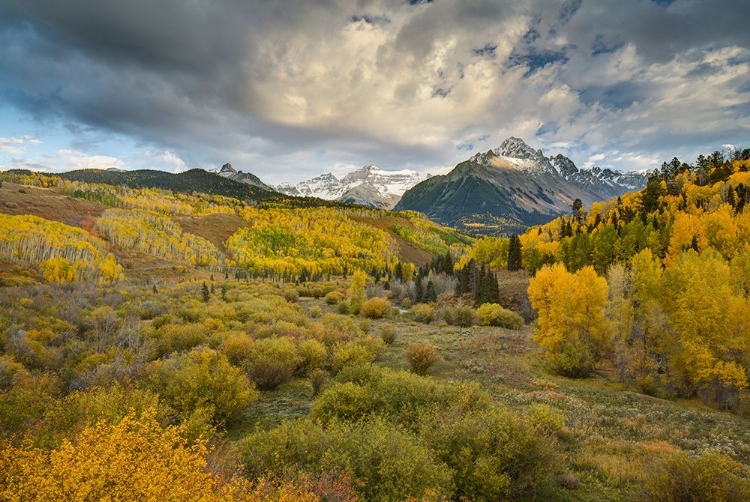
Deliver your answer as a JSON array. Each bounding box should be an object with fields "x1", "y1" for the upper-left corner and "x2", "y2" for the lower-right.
[{"x1": 394, "y1": 137, "x2": 648, "y2": 234}]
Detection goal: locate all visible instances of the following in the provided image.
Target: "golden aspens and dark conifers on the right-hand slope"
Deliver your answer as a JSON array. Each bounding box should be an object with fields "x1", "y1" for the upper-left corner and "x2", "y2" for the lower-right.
[{"x1": 521, "y1": 150, "x2": 750, "y2": 407}]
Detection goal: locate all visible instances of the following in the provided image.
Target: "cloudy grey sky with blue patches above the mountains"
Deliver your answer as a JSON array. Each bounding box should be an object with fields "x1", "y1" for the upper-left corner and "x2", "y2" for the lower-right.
[{"x1": 0, "y1": 0, "x2": 750, "y2": 184}]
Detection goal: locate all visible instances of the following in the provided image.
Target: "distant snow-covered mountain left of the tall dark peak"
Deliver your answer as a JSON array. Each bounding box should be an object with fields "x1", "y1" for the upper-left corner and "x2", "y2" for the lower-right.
[{"x1": 276, "y1": 166, "x2": 430, "y2": 209}]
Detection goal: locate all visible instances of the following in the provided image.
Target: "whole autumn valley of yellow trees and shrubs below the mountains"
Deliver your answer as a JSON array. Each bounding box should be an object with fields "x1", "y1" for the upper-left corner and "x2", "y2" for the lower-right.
[{"x1": 0, "y1": 150, "x2": 750, "y2": 501}]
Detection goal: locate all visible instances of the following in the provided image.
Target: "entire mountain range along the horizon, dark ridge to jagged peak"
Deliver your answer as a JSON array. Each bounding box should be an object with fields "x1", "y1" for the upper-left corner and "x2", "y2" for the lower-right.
[{"x1": 55, "y1": 137, "x2": 648, "y2": 234}]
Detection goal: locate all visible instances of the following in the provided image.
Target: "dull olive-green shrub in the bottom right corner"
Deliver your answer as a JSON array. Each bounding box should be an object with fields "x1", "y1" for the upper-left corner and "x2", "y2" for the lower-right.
[{"x1": 643, "y1": 452, "x2": 750, "y2": 502}]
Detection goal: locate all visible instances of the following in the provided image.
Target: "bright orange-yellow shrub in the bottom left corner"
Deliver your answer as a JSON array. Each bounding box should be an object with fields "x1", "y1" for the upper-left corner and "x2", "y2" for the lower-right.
[{"x1": 0, "y1": 413, "x2": 251, "y2": 500}]
